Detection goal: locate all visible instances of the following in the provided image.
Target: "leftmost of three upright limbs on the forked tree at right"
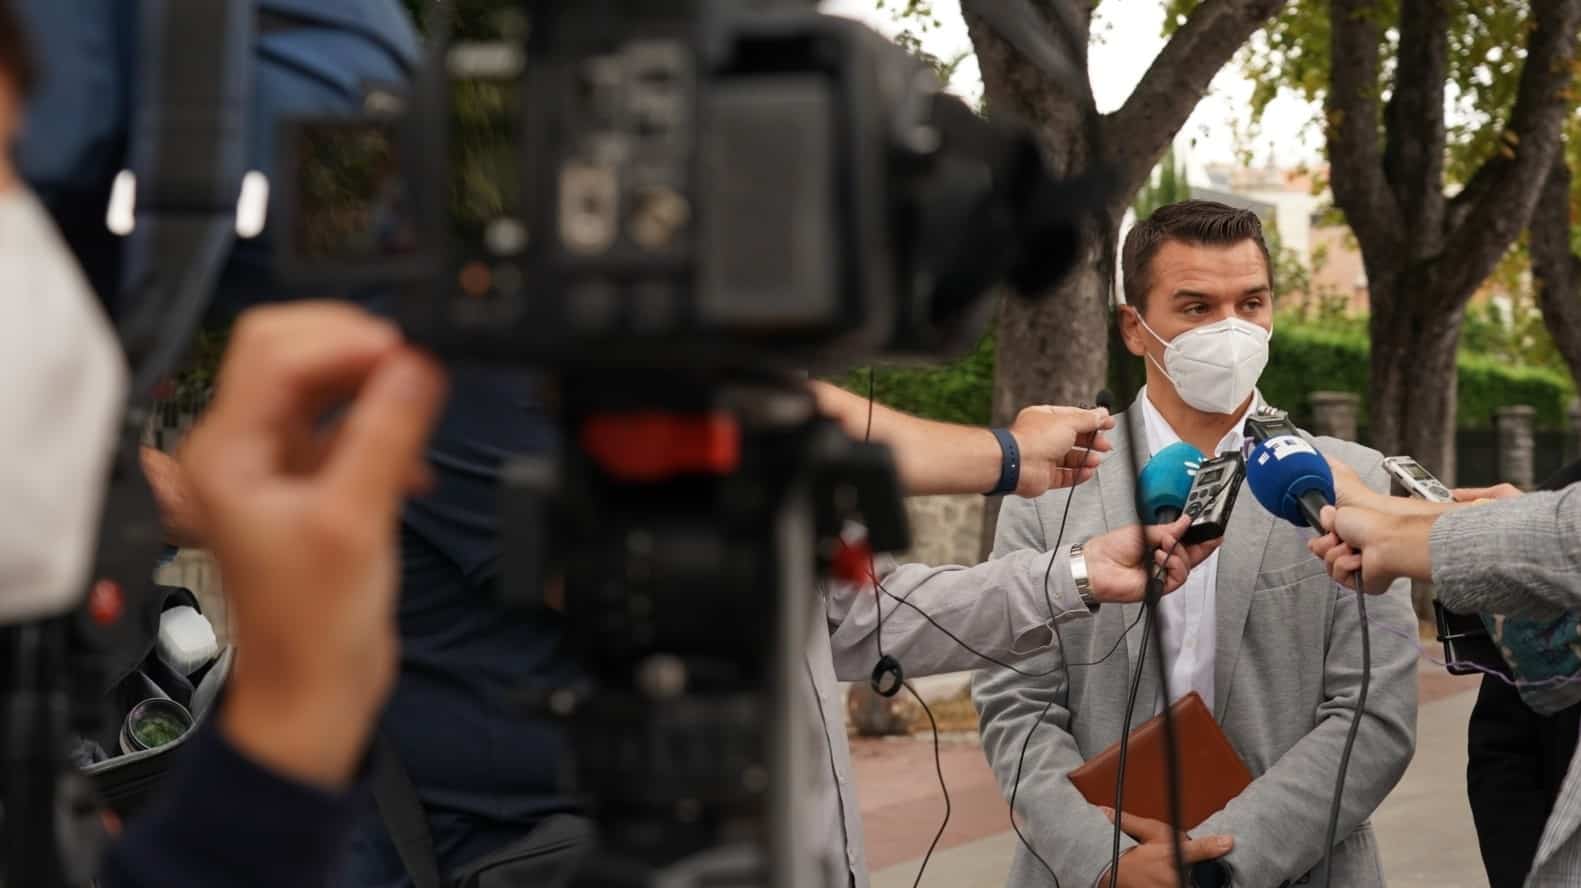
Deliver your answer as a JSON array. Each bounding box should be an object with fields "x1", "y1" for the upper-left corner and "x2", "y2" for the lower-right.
[{"x1": 1325, "y1": 0, "x2": 1401, "y2": 256}]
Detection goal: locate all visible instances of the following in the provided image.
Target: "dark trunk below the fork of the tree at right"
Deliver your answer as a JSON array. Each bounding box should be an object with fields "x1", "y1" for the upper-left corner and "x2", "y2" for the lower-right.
[{"x1": 1368, "y1": 292, "x2": 1464, "y2": 484}]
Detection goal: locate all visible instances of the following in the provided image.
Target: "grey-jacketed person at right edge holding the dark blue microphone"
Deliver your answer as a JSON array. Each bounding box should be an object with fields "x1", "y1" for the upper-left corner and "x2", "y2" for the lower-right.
[{"x1": 1311, "y1": 484, "x2": 1581, "y2": 888}]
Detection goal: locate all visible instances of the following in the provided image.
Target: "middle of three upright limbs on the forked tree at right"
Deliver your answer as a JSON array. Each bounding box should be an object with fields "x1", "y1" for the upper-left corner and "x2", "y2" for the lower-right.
[{"x1": 1383, "y1": 0, "x2": 1450, "y2": 252}]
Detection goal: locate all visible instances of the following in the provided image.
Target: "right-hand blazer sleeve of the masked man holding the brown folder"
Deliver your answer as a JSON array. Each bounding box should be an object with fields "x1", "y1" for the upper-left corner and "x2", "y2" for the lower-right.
[{"x1": 1192, "y1": 445, "x2": 1417, "y2": 886}]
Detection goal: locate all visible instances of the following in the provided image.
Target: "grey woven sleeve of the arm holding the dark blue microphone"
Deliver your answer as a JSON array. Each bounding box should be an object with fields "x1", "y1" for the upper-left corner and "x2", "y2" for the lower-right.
[{"x1": 1429, "y1": 484, "x2": 1581, "y2": 618}]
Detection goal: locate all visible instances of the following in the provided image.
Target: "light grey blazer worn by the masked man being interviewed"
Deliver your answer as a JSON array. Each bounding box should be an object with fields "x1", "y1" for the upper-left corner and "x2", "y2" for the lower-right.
[{"x1": 974, "y1": 414, "x2": 1417, "y2": 888}]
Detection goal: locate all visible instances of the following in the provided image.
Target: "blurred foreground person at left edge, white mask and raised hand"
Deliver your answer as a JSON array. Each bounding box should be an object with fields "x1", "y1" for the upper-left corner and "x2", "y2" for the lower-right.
[{"x1": 0, "y1": 3, "x2": 444, "y2": 888}]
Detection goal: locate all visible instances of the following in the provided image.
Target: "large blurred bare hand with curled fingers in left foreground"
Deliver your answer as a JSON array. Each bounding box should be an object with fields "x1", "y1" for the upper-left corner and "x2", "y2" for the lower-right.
[{"x1": 182, "y1": 303, "x2": 444, "y2": 787}]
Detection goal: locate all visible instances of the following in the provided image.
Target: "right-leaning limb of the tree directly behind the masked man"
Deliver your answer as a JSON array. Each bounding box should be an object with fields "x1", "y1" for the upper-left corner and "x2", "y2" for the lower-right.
[{"x1": 1104, "y1": 0, "x2": 1285, "y2": 199}]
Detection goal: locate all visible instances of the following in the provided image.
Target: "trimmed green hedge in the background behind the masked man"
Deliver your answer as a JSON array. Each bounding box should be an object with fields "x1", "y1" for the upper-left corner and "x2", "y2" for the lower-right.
[{"x1": 838, "y1": 321, "x2": 1576, "y2": 428}]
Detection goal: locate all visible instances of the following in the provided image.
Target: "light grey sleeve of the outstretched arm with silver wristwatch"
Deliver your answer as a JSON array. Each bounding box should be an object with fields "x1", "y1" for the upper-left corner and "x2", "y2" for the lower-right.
[{"x1": 827, "y1": 550, "x2": 1091, "y2": 681}]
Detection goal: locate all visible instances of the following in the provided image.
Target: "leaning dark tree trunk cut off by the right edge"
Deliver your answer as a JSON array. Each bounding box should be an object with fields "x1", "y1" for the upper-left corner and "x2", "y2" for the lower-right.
[{"x1": 1529, "y1": 156, "x2": 1581, "y2": 381}]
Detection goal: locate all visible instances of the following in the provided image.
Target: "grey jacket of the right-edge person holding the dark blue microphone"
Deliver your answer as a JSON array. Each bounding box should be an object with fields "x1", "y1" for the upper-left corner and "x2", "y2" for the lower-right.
[{"x1": 1432, "y1": 485, "x2": 1581, "y2": 888}]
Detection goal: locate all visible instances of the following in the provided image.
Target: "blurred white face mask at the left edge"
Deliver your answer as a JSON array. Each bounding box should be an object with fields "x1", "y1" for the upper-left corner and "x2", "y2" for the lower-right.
[{"x1": 0, "y1": 185, "x2": 126, "y2": 626}]
